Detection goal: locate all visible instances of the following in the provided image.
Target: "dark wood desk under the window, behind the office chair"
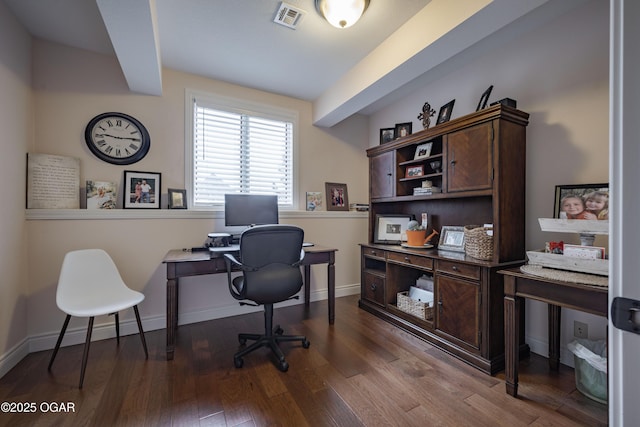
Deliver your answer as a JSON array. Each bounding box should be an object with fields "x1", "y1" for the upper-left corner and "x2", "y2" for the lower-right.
[{"x1": 162, "y1": 246, "x2": 337, "y2": 360}]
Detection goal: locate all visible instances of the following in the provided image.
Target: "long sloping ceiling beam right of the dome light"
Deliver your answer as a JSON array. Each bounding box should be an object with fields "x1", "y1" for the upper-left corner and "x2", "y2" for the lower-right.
[{"x1": 313, "y1": 0, "x2": 549, "y2": 127}]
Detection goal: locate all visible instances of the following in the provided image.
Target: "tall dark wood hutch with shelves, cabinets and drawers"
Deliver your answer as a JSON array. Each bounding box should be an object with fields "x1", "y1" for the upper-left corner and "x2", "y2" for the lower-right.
[{"x1": 359, "y1": 105, "x2": 529, "y2": 374}]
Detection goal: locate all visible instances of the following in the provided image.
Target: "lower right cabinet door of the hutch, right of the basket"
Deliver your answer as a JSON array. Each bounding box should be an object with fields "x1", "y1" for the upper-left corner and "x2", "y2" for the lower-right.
[{"x1": 436, "y1": 275, "x2": 480, "y2": 349}]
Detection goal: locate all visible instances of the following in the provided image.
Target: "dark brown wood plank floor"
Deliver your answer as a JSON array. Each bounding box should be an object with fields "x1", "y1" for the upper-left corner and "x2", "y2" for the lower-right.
[{"x1": 0, "y1": 296, "x2": 607, "y2": 427}]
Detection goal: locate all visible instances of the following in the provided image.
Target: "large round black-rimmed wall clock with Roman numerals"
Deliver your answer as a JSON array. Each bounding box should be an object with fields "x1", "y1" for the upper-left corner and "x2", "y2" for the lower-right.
[{"x1": 84, "y1": 113, "x2": 151, "y2": 165}]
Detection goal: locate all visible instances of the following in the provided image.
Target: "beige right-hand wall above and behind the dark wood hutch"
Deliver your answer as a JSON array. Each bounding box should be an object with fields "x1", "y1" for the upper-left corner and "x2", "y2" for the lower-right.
[{"x1": 369, "y1": 0, "x2": 609, "y2": 364}]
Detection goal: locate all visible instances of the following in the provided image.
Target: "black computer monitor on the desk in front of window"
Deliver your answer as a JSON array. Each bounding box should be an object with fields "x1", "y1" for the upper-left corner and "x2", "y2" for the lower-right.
[{"x1": 224, "y1": 194, "x2": 278, "y2": 227}]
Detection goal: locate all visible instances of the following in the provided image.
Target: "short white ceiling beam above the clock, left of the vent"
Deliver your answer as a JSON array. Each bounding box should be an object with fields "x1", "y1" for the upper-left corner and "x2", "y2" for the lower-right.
[{"x1": 96, "y1": 0, "x2": 162, "y2": 96}]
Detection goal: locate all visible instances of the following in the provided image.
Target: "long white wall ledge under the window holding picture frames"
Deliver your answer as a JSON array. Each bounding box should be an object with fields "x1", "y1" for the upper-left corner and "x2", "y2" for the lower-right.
[{"x1": 25, "y1": 209, "x2": 369, "y2": 221}]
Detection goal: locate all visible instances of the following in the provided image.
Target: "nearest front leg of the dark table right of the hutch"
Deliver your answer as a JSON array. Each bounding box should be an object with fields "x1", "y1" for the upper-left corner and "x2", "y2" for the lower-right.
[{"x1": 504, "y1": 276, "x2": 523, "y2": 397}]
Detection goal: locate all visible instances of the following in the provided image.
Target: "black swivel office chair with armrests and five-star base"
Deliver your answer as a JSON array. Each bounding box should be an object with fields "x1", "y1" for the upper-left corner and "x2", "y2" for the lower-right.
[{"x1": 225, "y1": 225, "x2": 309, "y2": 372}]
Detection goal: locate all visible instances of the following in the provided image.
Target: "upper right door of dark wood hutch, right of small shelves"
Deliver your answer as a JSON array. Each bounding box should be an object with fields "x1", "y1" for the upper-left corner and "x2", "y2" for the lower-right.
[{"x1": 447, "y1": 122, "x2": 493, "y2": 192}]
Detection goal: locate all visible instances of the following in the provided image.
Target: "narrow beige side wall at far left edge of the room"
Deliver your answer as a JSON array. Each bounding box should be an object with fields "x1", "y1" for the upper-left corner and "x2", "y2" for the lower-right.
[{"x1": 0, "y1": 2, "x2": 33, "y2": 376}]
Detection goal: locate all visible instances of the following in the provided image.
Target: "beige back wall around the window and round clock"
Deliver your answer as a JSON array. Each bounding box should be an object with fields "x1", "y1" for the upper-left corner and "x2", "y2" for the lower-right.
[{"x1": 1, "y1": 40, "x2": 368, "y2": 364}]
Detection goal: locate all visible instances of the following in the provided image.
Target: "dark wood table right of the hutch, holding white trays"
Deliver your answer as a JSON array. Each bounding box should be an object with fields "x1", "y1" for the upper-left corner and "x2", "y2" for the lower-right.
[{"x1": 499, "y1": 268, "x2": 608, "y2": 397}]
